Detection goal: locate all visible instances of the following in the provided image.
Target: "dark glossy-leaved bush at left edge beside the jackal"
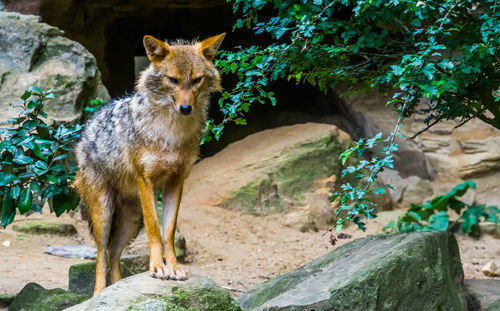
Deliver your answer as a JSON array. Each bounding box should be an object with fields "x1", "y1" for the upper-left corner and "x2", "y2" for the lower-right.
[{"x1": 0, "y1": 87, "x2": 81, "y2": 227}]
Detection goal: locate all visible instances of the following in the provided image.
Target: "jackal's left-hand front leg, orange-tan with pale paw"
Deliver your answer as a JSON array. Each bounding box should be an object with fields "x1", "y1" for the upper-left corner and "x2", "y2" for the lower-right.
[{"x1": 137, "y1": 177, "x2": 169, "y2": 279}]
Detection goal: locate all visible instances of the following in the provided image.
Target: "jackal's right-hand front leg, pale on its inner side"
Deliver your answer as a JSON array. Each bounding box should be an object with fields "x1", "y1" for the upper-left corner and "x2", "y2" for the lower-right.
[{"x1": 162, "y1": 177, "x2": 187, "y2": 280}]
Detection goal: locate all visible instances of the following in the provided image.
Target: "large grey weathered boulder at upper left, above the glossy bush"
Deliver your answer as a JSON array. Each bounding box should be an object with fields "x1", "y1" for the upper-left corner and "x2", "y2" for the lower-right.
[{"x1": 0, "y1": 12, "x2": 109, "y2": 121}]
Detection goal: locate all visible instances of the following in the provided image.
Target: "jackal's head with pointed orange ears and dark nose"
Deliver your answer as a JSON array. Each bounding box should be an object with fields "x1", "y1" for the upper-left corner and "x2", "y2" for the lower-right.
[{"x1": 137, "y1": 33, "x2": 226, "y2": 115}]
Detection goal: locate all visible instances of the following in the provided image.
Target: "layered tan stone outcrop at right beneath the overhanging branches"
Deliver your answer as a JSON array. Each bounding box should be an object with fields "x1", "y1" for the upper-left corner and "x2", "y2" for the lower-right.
[{"x1": 338, "y1": 90, "x2": 500, "y2": 207}]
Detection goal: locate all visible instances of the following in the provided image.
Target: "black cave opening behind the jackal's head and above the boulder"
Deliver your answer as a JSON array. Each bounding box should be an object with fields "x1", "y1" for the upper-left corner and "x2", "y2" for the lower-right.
[{"x1": 37, "y1": 0, "x2": 346, "y2": 156}]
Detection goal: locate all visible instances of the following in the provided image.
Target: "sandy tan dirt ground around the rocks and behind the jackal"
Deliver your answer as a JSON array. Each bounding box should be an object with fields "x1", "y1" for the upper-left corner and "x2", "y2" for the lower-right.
[{"x1": 0, "y1": 200, "x2": 500, "y2": 297}]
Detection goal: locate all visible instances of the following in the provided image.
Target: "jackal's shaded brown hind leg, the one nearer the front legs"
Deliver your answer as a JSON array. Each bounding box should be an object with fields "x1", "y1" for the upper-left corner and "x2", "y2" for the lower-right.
[{"x1": 108, "y1": 200, "x2": 141, "y2": 284}]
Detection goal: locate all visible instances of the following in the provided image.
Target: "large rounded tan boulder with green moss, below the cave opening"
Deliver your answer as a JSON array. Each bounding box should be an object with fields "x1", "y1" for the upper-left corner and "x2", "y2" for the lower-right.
[{"x1": 185, "y1": 123, "x2": 390, "y2": 228}]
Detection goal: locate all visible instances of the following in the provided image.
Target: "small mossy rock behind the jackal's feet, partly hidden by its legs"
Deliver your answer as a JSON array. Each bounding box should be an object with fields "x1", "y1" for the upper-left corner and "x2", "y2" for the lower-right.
[{"x1": 68, "y1": 255, "x2": 149, "y2": 296}]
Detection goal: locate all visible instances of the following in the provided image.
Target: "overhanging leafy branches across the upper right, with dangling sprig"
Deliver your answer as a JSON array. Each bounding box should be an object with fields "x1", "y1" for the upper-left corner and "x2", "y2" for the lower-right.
[{"x1": 211, "y1": 0, "x2": 500, "y2": 229}]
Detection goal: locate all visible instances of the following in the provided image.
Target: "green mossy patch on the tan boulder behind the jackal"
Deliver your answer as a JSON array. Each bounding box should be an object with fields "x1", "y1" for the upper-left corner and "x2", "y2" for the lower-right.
[{"x1": 220, "y1": 127, "x2": 348, "y2": 216}]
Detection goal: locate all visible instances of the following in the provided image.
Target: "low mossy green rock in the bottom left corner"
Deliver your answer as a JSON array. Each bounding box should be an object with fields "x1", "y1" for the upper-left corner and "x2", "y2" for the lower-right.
[{"x1": 9, "y1": 283, "x2": 89, "y2": 311}]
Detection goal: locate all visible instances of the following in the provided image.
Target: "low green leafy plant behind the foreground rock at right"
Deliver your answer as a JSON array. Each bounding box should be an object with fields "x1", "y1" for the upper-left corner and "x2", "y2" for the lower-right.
[{"x1": 384, "y1": 181, "x2": 500, "y2": 236}]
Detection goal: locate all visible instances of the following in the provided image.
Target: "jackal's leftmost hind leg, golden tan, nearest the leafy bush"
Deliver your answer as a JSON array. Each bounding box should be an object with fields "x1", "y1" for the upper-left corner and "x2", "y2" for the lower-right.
[{"x1": 86, "y1": 189, "x2": 114, "y2": 295}]
